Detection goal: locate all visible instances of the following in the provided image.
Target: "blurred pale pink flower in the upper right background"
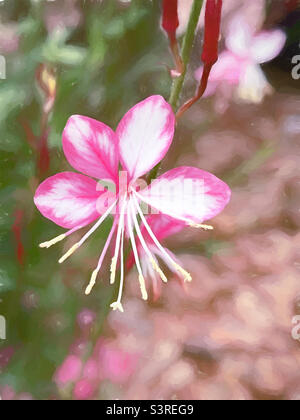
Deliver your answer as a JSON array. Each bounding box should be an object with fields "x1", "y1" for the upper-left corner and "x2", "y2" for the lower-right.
[{"x1": 195, "y1": 14, "x2": 286, "y2": 103}]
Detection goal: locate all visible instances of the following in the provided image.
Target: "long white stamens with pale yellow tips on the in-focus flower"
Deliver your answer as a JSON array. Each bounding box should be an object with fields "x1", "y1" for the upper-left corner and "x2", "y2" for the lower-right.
[{"x1": 40, "y1": 187, "x2": 192, "y2": 312}]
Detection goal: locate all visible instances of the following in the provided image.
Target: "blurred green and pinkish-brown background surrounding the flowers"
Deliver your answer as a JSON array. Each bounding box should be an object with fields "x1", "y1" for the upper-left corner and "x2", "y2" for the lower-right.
[{"x1": 0, "y1": 0, "x2": 300, "y2": 400}]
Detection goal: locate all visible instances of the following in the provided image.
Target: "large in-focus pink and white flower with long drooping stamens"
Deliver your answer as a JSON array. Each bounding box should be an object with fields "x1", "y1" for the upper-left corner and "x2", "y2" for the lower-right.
[{"x1": 34, "y1": 96, "x2": 230, "y2": 311}]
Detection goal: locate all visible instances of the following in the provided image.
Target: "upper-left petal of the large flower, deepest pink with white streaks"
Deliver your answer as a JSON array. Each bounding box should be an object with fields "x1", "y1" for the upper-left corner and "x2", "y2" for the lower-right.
[{"x1": 63, "y1": 115, "x2": 119, "y2": 182}]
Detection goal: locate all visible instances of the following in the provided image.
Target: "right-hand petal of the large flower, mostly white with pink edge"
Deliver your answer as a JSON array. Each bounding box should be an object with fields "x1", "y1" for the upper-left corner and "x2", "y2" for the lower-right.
[{"x1": 139, "y1": 166, "x2": 231, "y2": 223}]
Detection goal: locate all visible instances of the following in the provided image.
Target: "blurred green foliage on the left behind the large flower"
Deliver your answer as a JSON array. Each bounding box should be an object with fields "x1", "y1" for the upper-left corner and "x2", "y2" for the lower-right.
[{"x1": 0, "y1": 0, "x2": 170, "y2": 399}]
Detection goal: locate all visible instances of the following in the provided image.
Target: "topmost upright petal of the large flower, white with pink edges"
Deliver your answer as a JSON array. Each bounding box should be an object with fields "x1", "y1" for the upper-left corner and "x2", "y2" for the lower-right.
[{"x1": 117, "y1": 96, "x2": 175, "y2": 180}]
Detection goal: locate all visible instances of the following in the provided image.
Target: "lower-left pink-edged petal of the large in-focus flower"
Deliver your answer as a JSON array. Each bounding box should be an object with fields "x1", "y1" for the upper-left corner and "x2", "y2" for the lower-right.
[{"x1": 34, "y1": 172, "x2": 103, "y2": 229}]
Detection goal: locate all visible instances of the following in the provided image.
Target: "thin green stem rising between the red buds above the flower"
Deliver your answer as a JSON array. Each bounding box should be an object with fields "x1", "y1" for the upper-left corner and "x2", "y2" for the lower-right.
[{"x1": 169, "y1": 0, "x2": 204, "y2": 111}]
